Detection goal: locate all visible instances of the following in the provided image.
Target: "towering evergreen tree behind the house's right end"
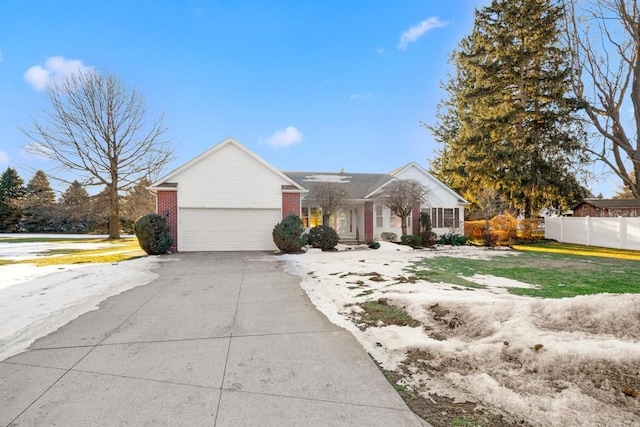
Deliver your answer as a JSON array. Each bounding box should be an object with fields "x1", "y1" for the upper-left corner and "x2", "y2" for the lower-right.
[{"x1": 428, "y1": 0, "x2": 584, "y2": 217}]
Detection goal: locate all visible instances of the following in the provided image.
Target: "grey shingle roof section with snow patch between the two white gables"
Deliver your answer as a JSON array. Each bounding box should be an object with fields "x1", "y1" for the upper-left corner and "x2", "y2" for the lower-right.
[{"x1": 284, "y1": 172, "x2": 393, "y2": 200}]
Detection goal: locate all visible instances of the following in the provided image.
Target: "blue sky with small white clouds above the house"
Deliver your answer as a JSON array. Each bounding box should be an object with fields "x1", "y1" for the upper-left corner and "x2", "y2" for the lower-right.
[{"x1": 0, "y1": 0, "x2": 613, "y2": 196}]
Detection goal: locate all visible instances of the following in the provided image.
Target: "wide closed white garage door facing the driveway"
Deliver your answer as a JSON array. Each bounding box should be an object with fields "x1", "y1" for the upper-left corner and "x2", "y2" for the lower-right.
[{"x1": 178, "y1": 208, "x2": 282, "y2": 252}]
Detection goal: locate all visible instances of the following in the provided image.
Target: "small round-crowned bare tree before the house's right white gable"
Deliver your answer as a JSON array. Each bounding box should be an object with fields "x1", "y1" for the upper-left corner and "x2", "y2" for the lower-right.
[{"x1": 378, "y1": 179, "x2": 429, "y2": 236}]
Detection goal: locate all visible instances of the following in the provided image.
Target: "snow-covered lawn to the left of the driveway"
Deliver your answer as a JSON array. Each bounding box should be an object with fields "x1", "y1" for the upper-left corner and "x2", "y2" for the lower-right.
[{"x1": 0, "y1": 236, "x2": 158, "y2": 360}]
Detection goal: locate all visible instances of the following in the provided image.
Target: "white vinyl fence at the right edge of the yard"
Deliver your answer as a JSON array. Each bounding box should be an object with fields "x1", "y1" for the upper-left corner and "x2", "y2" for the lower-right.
[{"x1": 544, "y1": 216, "x2": 640, "y2": 250}]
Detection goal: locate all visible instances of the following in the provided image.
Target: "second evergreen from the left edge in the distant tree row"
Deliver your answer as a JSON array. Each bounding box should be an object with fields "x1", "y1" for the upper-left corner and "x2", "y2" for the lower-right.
[{"x1": 21, "y1": 170, "x2": 56, "y2": 232}]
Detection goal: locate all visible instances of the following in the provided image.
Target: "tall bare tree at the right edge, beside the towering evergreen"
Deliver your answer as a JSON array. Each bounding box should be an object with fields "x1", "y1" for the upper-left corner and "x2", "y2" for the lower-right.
[{"x1": 564, "y1": 0, "x2": 640, "y2": 199}]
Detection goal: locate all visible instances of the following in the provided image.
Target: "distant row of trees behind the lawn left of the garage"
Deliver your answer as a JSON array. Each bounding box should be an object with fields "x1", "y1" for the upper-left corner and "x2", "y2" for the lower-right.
[{"x1": 0, "y1": 167, "x2": 155, "y2": 233}]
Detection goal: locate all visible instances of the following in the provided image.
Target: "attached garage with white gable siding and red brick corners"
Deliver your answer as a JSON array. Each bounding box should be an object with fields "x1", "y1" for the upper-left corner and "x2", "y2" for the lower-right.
[{"x1": 149, "y1": 138, "x2": 307, "y2": 252}]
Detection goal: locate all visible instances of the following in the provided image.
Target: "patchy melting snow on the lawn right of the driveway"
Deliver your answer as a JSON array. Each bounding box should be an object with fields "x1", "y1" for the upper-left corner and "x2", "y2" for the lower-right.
[{"x1": 280, "y1": 242, "x2": 640, "y2": 426}]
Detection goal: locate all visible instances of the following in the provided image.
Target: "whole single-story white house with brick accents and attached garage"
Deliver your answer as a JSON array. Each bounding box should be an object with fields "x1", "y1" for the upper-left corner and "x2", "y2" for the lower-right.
[{"x1": 149, "y1": 138, "x2": 468, "y2": 252}]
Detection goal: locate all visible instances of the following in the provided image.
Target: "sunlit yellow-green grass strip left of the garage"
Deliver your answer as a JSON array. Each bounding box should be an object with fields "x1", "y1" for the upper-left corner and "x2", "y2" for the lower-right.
[{"x1": 0, "y1": 238, "x2": 145, "y2": 267}]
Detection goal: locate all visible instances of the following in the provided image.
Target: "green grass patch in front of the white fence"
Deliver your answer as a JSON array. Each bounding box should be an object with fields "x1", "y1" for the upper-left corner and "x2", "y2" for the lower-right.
[{"x1": 410, "y1": 246, "x2": 640, "y2": 298}]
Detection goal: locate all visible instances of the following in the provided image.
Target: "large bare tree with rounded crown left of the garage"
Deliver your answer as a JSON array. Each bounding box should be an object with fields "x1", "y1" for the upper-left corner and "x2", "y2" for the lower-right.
[{"x1": 23, "y1": 70, "x2": 173, "y2": 239}]
